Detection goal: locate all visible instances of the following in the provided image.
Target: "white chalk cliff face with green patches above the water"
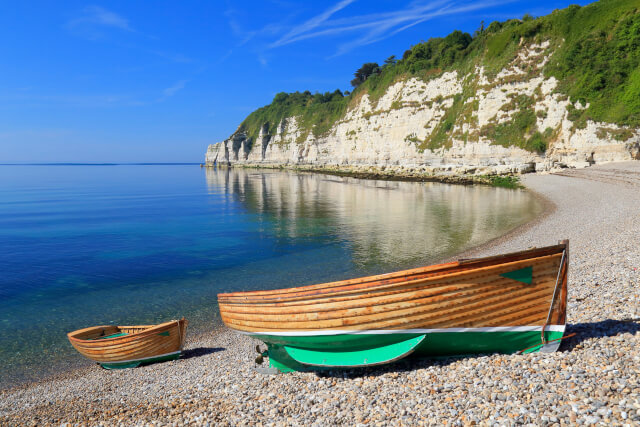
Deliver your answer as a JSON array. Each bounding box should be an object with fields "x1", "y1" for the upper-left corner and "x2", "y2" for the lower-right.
[{"x1": 206, "y1": 42, "x2": 640, "y2": 175}]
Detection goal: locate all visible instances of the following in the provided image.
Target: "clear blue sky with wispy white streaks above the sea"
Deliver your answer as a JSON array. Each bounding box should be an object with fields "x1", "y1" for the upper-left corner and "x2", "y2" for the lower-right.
[{"x1": 0, "y1": 0, "x2": 589, "y2": 163}]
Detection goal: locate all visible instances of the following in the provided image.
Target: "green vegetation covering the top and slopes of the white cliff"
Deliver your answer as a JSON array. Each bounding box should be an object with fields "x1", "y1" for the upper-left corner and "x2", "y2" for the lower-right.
[{"x1": 240, "y1": 0, "x2": 640, "y2": 151}]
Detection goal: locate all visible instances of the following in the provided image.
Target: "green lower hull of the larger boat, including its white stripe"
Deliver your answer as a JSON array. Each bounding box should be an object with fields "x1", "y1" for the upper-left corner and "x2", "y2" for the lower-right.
[{"x1": 249, "y1": 325, "x2": 564, "y2": 372}]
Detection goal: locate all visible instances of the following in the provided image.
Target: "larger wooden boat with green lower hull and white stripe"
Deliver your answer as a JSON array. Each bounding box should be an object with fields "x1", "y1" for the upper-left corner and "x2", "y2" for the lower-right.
[{"x1": 218, "y1": 241, "x2": 569, "y2": 371}]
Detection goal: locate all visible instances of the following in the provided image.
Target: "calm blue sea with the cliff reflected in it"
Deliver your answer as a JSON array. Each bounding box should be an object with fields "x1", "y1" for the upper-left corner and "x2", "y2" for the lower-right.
[{"x1": 0, "y1": 165, "x2": 541, "y2": 388}]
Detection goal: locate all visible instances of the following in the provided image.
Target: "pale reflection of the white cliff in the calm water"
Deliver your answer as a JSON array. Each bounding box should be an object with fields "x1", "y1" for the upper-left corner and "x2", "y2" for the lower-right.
[{"x1": 206, "y1": 168, "x2": 541, "y2": 271}]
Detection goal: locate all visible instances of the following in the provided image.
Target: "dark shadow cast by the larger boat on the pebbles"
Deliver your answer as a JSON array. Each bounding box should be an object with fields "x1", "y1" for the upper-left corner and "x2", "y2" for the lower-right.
[{"x1": 315, "y1": 318, "x2": 640, "y2": 378}]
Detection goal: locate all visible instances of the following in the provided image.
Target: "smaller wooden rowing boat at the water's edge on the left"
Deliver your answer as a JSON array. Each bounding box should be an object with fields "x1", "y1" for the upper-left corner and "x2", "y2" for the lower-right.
[{"x1": 67, "y1": 318, "x2": 189, "y2": 369}]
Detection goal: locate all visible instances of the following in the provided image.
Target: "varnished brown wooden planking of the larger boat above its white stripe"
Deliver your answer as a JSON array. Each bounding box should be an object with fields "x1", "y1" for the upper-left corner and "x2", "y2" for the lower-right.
[{"x1": 219, "y1": 244, "x2": 566, "y2": 332}]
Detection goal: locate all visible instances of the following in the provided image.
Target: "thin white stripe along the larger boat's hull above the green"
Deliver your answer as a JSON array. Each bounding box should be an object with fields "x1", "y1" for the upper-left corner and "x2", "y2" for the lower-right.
[{"x1": 236, "y1": 325, "x2": 566, "y2": 337}]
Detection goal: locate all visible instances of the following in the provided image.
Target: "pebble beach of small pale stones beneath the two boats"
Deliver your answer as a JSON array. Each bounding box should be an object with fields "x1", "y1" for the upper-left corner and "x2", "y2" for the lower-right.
[{"x1": 0, "y1": 161, "x2": 640, "y2": 426}]
